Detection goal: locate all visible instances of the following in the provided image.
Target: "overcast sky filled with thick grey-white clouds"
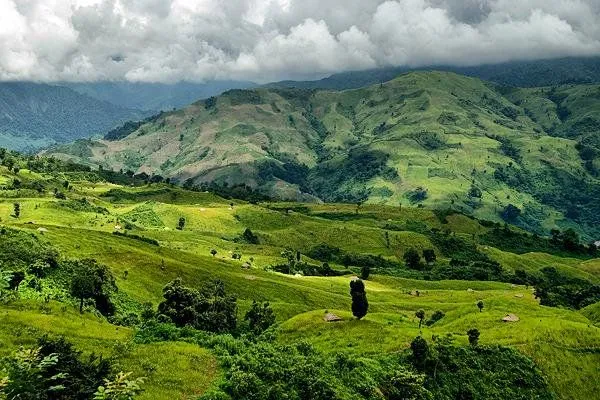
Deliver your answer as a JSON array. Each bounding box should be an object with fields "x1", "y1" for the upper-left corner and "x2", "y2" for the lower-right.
[{"x1": 0, "y1": 0, "x2": 600, "y2": 82}]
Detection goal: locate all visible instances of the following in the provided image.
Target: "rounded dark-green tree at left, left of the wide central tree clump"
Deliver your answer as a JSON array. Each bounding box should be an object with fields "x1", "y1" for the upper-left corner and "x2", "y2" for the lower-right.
[{"x1": 70, "y1": 259, "x2": 117, "y2": 315}]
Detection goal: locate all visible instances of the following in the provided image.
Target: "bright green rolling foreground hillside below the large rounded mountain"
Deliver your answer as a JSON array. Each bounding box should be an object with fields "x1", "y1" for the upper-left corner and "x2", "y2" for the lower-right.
[{"x1": 0, "y1": 151, "x2": 600, "y2": 400}]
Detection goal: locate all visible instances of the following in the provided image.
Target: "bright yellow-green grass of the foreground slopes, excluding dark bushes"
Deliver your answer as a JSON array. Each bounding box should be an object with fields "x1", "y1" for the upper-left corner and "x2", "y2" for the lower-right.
[{"x1": 0, "y1": 171, "x2": 600, "y2": 399}]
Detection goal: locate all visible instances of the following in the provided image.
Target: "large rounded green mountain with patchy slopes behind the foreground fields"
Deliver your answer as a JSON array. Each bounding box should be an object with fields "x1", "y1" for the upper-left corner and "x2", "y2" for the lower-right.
[{"x1": 49, "y1": 71, "x2": 600, "y2": 240}]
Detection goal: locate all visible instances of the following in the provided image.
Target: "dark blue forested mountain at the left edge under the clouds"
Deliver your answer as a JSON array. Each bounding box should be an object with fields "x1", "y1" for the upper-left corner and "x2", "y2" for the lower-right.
[{"x1": 0, "y1": 82, "x2": 148, "y2": 150}]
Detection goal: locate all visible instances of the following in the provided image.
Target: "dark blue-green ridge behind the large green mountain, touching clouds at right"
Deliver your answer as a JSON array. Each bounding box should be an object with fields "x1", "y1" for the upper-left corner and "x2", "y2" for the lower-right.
[{"x1": 265, "y1": 57, "x2": 600, "y2": 90}]
